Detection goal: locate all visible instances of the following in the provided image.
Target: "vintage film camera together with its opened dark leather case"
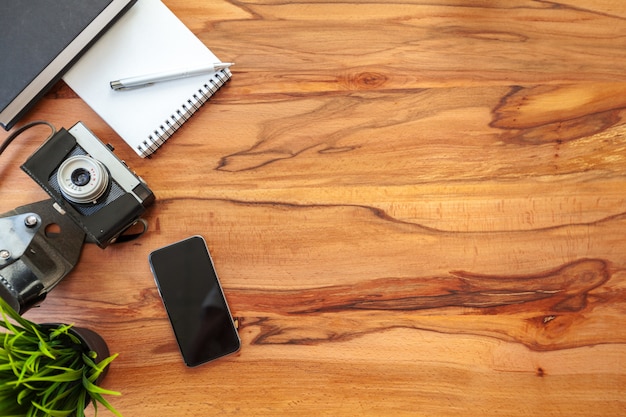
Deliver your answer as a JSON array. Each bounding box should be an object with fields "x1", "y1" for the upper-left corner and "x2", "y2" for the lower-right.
[{"x1": 0, "y1": 122, "x2": 155, "y2": 313}]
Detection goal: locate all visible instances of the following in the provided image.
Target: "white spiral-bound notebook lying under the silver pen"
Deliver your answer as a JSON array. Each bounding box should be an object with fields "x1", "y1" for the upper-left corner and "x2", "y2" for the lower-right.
[{"x1": 63, "y1": 0, "x2": 232, "y2": 158}]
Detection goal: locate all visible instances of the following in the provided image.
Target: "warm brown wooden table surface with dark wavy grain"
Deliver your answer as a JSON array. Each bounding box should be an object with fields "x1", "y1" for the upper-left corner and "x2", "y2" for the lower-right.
[{"x1": 0, "y1": 0, "x2": 626, "y2": 417}]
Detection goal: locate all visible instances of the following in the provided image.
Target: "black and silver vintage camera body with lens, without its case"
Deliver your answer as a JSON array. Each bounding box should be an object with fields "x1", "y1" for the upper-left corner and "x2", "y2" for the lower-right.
[{"x1": 21, "y1": 122, "x2": 155, "y2": 248}]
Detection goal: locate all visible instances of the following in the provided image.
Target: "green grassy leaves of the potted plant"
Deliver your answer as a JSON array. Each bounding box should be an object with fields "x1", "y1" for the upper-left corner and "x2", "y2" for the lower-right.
[{"x1": 0, "y1": 298, "x2": 121, "y2": 417}]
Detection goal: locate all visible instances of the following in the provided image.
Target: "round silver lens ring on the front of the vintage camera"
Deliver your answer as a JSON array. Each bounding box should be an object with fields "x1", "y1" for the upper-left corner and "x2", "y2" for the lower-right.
[{"x1": 57, "y1": 155, "x2": 109, "y2": 204}]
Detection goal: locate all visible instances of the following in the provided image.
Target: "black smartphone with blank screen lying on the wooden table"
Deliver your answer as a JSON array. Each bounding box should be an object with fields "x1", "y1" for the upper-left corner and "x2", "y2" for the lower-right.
[{"x1": 149, "y1": 236, "x2": 241, "y2": 366}]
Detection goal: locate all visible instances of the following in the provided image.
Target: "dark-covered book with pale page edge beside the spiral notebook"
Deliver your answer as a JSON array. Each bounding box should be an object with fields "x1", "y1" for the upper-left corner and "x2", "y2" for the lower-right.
[{"x1": 0, "y1": 0, "x2": 136, "y2": 130}]
